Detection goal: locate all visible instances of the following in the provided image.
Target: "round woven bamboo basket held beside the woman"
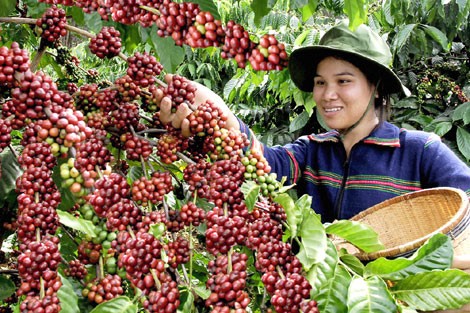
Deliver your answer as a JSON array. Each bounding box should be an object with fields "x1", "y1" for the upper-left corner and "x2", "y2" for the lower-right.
[{"x1": 337, "y1": 187, "x2": 470, "y2": 261}]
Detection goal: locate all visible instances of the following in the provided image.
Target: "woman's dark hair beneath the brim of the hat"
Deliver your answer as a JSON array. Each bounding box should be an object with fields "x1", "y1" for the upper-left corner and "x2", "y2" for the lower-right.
[{"x1": 314, "y1": 53, "x2": 391, "y2": 123}]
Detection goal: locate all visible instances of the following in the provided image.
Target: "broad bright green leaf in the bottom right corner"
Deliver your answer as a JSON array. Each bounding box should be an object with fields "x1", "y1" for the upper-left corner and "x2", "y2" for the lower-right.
[{"x1": 391, "y1": 269, "x2": 470, "y2": 311}]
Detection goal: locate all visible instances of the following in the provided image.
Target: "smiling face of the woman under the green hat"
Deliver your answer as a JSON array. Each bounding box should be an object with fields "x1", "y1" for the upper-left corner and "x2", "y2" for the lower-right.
[{"x1": 313, "y1": 57, "x2": 377, "y2": 131}]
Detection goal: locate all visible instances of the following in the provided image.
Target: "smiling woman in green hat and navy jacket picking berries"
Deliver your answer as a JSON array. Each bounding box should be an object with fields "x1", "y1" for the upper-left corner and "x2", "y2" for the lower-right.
[{"x1": 160, "y1": 23, "x2": 470, "y2": 268}]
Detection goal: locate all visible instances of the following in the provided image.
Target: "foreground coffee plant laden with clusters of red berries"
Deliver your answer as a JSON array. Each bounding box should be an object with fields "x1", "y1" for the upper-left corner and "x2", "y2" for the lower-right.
[{"x1": 0, "y1": 0, "x2": 470, "y2": 313}]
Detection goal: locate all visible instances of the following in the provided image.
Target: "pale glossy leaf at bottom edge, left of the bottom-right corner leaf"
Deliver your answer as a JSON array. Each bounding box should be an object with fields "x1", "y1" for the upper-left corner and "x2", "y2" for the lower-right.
[{"x1": 347, "y1": 276, "x2": 397, "y2": 313}]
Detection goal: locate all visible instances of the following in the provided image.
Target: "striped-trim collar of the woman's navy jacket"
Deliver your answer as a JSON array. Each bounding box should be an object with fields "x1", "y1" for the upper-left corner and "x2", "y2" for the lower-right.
[{"x1": 308, "y1": 122, "x2": 400, "y2": 147}]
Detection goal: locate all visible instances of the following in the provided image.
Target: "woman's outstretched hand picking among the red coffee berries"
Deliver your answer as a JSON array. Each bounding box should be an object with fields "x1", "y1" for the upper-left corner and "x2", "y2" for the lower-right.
[{"x1": 157, "y1": 74, "x2": 240, "y2": 137}]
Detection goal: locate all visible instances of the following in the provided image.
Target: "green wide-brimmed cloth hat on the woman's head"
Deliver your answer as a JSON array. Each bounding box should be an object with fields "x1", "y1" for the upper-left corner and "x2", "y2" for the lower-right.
[{"x1": 289, "y1": 22, "x2": 409, "y2": 94}]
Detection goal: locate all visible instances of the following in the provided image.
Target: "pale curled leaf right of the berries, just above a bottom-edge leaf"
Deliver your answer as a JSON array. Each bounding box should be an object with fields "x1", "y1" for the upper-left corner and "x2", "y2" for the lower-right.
[{"x1": 308, "y1": 240, "x2": 339, "y2": 298}]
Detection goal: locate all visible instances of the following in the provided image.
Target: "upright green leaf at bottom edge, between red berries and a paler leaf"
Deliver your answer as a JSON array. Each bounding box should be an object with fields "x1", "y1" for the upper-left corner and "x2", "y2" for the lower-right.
[{"x1": 314, "y1": 265, "x2": 351, "y2": 313}]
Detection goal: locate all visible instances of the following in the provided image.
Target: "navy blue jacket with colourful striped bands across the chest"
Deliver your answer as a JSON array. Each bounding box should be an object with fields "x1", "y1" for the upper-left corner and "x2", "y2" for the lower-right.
[{"x1": 240, "y1": 122, "x2": 470, "y2": 222}]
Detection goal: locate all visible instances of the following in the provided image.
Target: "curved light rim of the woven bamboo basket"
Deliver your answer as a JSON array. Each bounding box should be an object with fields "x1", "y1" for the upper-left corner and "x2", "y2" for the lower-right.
[{"x1": 350, "y1": 187, "x2": 470, "y2": 260}]
